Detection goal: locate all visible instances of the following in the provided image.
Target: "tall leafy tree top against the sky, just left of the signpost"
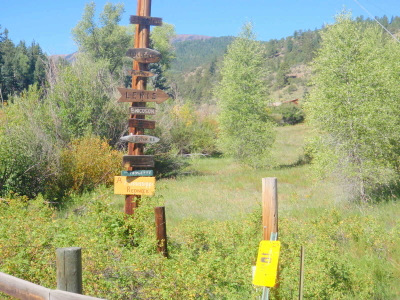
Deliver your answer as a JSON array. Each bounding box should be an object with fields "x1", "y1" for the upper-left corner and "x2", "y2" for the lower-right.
[{"x1": 72, "y1": 2, "x2": 132, "y2": 73}]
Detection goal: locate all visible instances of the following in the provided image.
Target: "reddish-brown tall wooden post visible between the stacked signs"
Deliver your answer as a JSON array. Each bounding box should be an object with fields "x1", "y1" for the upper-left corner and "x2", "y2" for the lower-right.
[{"x1": 125, "y1": 0, "x2": 151, "y2": 215}]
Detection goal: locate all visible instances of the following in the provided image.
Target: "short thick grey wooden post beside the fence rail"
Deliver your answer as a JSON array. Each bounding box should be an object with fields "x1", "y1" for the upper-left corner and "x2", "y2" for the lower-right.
[{"x1": 56, "y1": 247, "x2": 82, "y2": 294}]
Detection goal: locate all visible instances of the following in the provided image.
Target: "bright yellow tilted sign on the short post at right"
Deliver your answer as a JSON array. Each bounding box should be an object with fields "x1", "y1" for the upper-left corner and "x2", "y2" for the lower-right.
[{"x1": 253, "y1": 241, "x2": 281, "y2": 287}]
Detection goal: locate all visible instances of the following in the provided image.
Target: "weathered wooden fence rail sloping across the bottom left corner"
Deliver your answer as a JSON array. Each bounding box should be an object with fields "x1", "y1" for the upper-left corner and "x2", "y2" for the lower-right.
[{"x1": 0, "y1": 272, "x2": 105, "y2": 300}]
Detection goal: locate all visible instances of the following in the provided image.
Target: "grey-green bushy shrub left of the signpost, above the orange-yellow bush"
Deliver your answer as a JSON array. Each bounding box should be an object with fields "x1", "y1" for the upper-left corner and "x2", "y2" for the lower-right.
[{"x1": 45, "y1": 54, "x2": 126, "y2": 144}]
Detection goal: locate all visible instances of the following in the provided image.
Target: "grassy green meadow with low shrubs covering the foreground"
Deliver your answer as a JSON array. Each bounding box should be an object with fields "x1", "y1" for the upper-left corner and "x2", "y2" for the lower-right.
[{"x1": 0, "y1": 124, "x2": 400, "y2": 299}]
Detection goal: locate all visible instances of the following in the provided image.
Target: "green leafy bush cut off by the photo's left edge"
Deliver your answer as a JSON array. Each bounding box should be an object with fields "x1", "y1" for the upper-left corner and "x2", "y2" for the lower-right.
[{"x1": 0, "y1": 86, "x2": 59, "y2": 197}]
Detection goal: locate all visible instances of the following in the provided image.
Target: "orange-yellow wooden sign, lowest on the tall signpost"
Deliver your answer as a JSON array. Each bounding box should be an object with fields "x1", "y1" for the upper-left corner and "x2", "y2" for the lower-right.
[{"x1": 114, "y1": 176, "x2": 156, "y2": 196}]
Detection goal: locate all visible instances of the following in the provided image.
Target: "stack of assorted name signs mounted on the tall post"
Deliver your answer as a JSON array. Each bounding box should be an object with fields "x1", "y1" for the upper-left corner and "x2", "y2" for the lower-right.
[{"x1": 114, "y1": 16, "x2": 169, "y2": 195}]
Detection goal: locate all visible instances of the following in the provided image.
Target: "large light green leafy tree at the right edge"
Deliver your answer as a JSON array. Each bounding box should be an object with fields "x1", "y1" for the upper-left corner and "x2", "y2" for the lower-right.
[{"x1": 305, "y1": 13, "x2": 400, "y2": 200}]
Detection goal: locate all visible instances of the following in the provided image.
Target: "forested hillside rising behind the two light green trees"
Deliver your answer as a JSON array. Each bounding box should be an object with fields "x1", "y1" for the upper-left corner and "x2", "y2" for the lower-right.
[{"x1": 170, "y1": 16, "x2": 400, "y2": 104}]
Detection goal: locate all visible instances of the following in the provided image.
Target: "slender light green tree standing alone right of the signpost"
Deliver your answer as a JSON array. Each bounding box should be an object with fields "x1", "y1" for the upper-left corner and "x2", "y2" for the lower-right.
[{"x1": 215, "y1": 24, "x2": 274, "y2": 167}]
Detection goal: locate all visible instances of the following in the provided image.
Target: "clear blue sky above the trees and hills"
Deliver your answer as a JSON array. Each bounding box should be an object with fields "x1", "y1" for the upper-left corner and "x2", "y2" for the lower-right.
[{"x1": 0, "y1": 0, "x2": 400, "y2": 55}]
